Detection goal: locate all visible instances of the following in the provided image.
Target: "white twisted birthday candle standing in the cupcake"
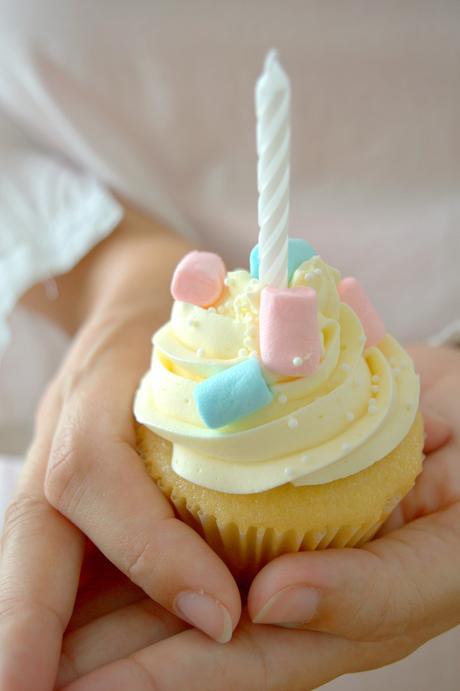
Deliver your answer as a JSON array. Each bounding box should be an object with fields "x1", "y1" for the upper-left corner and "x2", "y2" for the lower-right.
[{"x1": 256, "y1": 51, "x2": 291, "y2": 288}]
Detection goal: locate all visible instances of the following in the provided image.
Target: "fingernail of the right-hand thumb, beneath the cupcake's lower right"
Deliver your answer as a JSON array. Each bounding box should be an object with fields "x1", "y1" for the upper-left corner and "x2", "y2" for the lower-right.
[{"x1": 252, "y1": 586, "x2": 320, "y2": 626}]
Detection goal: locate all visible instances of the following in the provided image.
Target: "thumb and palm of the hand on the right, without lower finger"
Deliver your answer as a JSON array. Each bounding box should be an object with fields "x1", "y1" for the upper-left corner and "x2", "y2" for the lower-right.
[{"x1": 248, "y1": 346, "x2": 460, "y2": 666}]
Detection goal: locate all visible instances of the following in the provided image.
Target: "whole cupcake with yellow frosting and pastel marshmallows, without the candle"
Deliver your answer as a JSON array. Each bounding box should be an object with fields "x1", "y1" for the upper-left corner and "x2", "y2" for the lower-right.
[{"x1": 134, "y1": 246, "x2": 423, "y2": 581}]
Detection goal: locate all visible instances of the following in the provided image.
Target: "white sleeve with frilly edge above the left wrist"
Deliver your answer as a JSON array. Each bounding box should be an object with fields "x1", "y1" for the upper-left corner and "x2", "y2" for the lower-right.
[{"x1": 0, "y1": 112, "x2": 123, "y2": 353}]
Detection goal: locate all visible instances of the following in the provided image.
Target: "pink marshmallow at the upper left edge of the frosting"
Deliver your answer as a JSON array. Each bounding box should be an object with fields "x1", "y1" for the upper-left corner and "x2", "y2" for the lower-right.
[{"x1": 171, "y1": 250, "x2": 226, "y2": 307}]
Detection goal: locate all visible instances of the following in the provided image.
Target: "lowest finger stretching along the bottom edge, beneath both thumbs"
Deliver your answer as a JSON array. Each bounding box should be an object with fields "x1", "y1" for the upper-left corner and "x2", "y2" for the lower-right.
[{"x1": 59, "y1": 622, "x2": 367, "y2": 691}]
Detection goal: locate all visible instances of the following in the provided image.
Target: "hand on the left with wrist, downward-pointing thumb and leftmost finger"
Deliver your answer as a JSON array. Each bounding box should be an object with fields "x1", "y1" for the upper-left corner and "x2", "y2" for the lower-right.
[{"x1": 0, "y1": 212, "x2": 240, "y2": 691}]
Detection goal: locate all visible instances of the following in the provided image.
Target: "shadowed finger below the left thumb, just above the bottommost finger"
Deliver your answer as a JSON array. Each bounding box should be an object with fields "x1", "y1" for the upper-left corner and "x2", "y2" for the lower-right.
[{"x1": 57, "y1": 599, "x2": 187, "y2": 688}]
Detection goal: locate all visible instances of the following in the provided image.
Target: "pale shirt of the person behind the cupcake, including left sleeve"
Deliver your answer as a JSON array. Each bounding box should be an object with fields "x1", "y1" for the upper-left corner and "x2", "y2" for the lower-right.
[{"x1": 0, "y1": 0, "x2": 460, "y2": 352}]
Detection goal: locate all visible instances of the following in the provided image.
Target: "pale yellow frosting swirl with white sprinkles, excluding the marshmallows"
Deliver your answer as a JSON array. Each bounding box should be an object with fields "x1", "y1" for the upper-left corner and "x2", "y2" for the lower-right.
[{"x1": 134, "y1": 257, "x2": 419, "y2": 494}]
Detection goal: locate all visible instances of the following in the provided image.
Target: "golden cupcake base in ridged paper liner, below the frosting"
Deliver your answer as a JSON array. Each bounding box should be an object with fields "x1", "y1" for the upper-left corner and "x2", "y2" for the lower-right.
[{"x1": 137, "y1": 414, "x2": 424, "y2": 582}]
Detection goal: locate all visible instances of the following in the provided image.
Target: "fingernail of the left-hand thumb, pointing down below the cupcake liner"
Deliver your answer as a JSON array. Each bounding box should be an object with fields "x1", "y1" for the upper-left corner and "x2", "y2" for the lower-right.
[{"x1": 174, "y1": 591, "x2": 233, "y2": 643}]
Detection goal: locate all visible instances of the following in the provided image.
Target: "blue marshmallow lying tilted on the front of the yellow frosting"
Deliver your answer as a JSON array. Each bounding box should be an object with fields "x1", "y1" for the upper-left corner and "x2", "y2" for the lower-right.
[{"x1": 194, "y1": 357, "x2": 273, "y2": 429}]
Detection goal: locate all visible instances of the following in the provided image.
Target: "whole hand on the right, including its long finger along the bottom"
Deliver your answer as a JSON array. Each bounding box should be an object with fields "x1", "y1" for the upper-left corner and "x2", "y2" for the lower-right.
[{"x1": 54, "y1": 348, "x2": 460, "y2": 691}]
